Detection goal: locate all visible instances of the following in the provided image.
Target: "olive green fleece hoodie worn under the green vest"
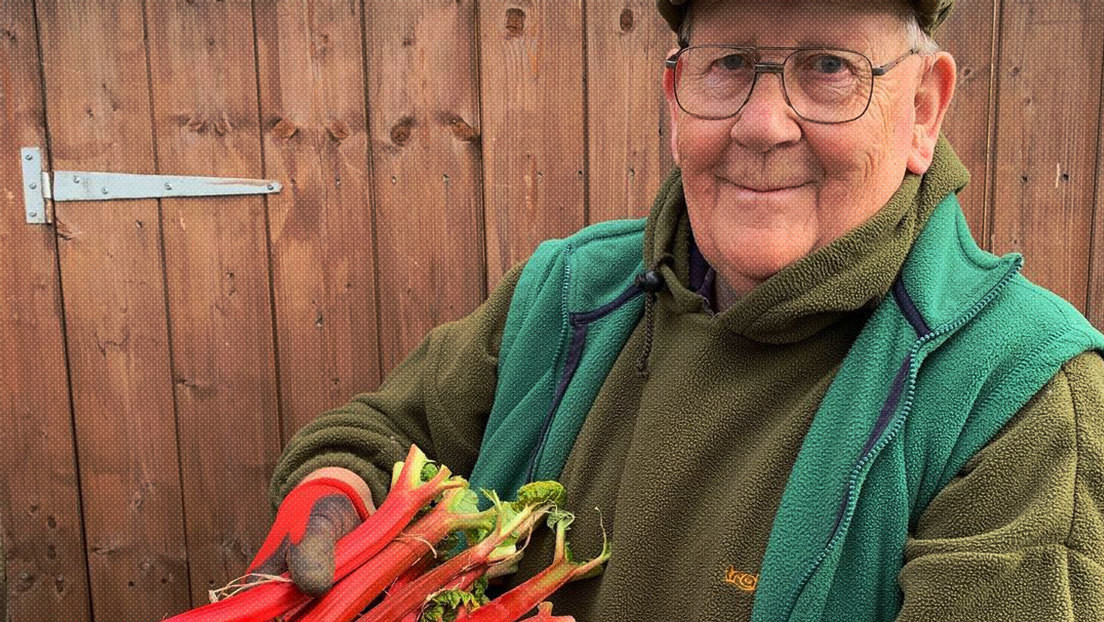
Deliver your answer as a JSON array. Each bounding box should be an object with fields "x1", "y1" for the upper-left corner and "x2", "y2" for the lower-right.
[{"x1": 273, "y1": 138, "x2": 1104, "y2": 621}]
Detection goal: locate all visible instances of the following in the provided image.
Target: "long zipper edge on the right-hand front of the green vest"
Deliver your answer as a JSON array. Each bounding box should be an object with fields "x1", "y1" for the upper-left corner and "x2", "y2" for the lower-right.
[{"x1": 788, "y1": 256, "x2": 1023, "y2": 616}]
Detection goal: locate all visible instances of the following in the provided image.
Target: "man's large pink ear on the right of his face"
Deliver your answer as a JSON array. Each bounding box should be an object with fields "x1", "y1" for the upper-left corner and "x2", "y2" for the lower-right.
[{"x1": 907, "y1": 52, "x2": 958, "y2": 175}]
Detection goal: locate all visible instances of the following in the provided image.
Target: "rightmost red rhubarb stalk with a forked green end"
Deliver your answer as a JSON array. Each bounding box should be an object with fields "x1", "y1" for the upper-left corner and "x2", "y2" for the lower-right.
[{"x1": 456, "y1": 514, "x2": 609, "y2": 622}]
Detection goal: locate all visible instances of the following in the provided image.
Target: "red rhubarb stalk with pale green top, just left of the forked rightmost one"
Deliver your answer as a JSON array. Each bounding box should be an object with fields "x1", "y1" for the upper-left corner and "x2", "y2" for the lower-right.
[{"x1": 353, "y1": 506, "x2": 548, "y2": 622}]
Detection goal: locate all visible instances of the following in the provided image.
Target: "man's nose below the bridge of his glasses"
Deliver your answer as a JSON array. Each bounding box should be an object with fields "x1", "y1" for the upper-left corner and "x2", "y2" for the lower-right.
[{"x1": 732, "y1": 73, "x2": 802, "y2": 152}]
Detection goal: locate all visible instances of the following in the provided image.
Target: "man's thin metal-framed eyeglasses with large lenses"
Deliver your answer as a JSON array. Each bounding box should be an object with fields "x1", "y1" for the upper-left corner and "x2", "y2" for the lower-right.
[{"x1": 666, "y1": 45, "x2": 919, "y2": 124}]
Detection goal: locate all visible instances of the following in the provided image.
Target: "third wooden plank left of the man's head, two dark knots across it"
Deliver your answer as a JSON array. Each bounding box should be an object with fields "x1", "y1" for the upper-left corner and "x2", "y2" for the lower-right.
[{"x1": 364, "y1": 0, "x2": 486, "y2": 372}]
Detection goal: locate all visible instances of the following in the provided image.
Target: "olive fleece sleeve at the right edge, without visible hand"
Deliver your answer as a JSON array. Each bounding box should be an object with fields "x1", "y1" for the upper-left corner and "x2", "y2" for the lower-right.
[{"x1": 898, "y1": 351, "x2": 1104, "y2": 622}]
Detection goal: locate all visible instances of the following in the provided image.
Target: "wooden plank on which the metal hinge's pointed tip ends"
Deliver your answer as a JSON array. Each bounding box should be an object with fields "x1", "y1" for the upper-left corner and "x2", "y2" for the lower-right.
[{"x1": 255, "y1": 0, "x2": 380, "y2": 440}]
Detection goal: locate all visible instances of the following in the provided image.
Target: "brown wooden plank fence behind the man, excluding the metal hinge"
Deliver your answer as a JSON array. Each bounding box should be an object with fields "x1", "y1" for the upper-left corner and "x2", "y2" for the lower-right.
[{"x1": 0, "y1": 0, "x2": 1104, "y2": 621}]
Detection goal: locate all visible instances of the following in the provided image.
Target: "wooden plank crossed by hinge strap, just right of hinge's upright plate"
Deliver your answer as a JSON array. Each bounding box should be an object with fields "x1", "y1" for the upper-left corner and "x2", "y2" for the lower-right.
[{"x1": 36, "y1": 0, "x2": 189, "y2": 620}]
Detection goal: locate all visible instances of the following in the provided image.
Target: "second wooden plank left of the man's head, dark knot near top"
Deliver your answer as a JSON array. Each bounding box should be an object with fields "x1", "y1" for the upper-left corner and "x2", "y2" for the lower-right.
[{"x1": 479, "y1": 0, "x2": 586, "y2": 287}]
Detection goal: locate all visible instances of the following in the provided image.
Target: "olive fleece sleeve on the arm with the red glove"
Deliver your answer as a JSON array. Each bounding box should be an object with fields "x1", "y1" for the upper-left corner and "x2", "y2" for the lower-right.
[{"x1": 269, "y1": 262, "x2": 524, "y2": 509}]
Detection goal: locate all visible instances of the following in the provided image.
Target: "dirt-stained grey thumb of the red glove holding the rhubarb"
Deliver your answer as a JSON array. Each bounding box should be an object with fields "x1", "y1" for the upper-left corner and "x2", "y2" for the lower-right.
[{"x1": 287, "y1": 495, "x2": 360, "y2": 597}]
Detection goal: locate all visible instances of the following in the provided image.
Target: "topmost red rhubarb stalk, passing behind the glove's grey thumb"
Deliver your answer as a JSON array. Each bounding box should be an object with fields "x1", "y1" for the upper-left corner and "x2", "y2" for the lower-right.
[{"x1": 166, "y1": 445, "x2": 467, "y2": 622}]
